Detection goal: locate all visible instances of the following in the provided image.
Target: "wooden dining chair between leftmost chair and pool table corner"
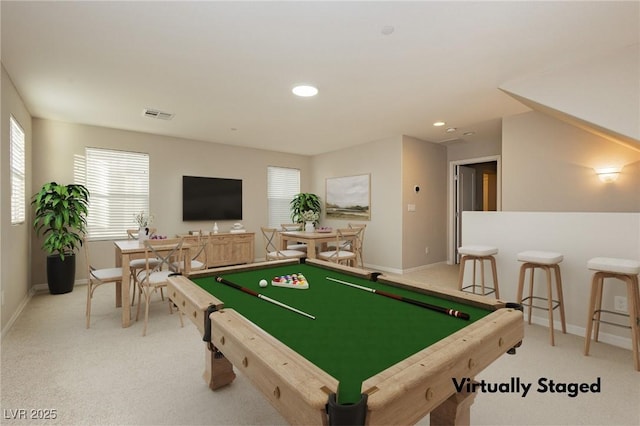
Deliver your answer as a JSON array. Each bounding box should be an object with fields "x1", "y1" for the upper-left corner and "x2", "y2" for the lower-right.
[{"x1": 136, "y1": 238, "x2": 184, "y2": 336}]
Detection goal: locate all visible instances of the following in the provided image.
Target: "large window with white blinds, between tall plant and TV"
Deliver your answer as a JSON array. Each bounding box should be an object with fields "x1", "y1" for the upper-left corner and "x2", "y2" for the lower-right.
[{"x1": 85, "y1": 148, "x2": 150, "y2": 239}]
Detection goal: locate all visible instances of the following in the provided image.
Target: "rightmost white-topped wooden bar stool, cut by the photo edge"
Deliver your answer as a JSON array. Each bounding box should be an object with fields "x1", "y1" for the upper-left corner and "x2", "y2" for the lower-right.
[{"x1": 584, "y1": 257, "x2": 640, "y2": 371}]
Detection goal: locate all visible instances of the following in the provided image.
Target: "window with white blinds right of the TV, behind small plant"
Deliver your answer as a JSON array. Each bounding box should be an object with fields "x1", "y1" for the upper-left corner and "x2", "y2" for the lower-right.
[{"x1": 267, "y1": 166, "x2": 300, "y2": 228}]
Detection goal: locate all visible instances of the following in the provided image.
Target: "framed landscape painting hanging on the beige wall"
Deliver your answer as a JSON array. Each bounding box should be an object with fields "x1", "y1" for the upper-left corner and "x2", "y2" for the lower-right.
[{"x1": 325, "y1": 174, "x2": 371, "y2": 220}]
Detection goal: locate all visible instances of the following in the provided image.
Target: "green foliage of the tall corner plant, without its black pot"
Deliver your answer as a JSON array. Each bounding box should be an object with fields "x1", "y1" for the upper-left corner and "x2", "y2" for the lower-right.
[{"x1": 31, "y1": 182, "x2": 89, "y2": 260}]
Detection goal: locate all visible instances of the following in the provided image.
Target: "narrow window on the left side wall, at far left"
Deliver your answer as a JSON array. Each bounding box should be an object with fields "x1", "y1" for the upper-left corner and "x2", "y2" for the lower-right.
[{"x1": 9, "y1": 116, "x2": 26, "y2": 225}]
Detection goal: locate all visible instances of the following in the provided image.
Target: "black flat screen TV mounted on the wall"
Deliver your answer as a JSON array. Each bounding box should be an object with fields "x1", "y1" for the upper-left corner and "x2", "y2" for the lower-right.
[{"x1": 182, "y1": 176, "x2": 242, "y2": 221}]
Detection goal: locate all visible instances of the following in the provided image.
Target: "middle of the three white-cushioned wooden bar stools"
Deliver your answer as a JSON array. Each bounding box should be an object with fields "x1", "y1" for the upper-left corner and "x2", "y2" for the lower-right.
[{"x1": 517, "y1": 250, "x2": 567, "y2": 346}]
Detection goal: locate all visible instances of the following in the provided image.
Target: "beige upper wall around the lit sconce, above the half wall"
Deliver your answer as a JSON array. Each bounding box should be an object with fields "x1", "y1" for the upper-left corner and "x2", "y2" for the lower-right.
[{"x1": 502, "y1": 112, "x2": 640, "y2": 212}]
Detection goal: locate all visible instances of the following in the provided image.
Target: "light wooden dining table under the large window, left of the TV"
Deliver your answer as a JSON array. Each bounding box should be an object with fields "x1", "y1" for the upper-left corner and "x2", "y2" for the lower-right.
[{"x1": 113, "y1": 239, "x2": 191, "y2": 328}]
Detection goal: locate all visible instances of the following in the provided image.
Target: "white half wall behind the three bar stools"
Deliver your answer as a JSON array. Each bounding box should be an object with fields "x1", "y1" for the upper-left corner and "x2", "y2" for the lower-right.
[{"x1": 462, "y1": 212, "x2": 640, "y2": 348}]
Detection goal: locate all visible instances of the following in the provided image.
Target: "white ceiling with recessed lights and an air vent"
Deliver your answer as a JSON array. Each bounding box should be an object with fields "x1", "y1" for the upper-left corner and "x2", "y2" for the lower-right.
[{"x1": 1, "y1": 0, "x2": 640, "y2": 155}]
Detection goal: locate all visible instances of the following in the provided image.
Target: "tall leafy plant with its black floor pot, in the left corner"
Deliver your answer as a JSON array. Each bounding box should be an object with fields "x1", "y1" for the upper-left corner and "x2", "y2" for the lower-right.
[{"x1": 31, "y1": 182, "x2": 89, "y2": 294}]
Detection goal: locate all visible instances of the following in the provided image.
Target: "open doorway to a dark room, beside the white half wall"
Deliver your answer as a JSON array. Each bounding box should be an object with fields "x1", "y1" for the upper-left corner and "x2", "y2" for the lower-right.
[{"x1": 447, "y1": 156, "x2": 501, "y2": 264}]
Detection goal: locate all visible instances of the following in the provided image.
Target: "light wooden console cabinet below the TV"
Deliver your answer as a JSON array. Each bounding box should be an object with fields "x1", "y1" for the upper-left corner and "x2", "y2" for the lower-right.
[{"x1": 180, "y1": 232, "x2": 255, "y2": 268}]
